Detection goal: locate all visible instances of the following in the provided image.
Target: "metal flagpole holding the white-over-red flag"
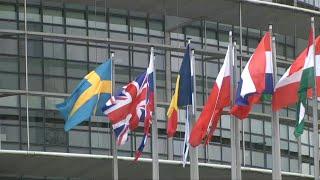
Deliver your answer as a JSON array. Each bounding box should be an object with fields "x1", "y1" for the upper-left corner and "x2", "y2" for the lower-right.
[{"x1": 229, "y1": 31, "x2": 241, "y2": 180}]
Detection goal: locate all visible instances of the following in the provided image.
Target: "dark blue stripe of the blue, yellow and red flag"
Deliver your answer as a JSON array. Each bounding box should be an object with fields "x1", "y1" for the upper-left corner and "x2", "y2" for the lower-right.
[{"x1": 178, "y1": 44, "x2": 193, "y2": 107}]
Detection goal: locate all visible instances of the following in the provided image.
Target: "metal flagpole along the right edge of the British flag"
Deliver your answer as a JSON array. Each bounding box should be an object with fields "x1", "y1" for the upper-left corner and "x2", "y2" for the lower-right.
[{"x1": 150, "y1": 47, "x2": 159, "y2": 180}]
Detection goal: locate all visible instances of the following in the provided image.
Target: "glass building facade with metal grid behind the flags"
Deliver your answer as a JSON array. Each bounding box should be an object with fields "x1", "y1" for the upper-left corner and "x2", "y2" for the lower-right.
[{"x1": 0, "y1": 0, "x2": 320, "y2": 179}]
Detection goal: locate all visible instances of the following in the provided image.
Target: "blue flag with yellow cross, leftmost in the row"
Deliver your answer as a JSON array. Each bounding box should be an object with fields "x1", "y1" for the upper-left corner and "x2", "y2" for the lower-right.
[{"x1": 56, "y1": 60, "x2": 112, "y2": 131}]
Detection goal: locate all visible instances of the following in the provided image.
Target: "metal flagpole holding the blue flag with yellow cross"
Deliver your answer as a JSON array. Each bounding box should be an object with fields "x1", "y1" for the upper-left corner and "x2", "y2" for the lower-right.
[{"x1": 110, "y1": 52, "x2": 119, "y2": 180}]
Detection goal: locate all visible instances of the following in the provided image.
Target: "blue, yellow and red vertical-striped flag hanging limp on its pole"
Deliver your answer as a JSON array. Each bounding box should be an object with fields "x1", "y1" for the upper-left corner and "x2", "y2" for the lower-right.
[{"x1": 167, "y1": 44, "x2": 192, "y2": 137}]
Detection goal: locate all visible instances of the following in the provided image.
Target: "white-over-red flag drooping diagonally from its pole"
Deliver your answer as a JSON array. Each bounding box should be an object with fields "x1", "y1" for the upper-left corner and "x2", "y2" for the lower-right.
[{"x1": 189, "y1": 44, "x2": 234, "y2": 147}]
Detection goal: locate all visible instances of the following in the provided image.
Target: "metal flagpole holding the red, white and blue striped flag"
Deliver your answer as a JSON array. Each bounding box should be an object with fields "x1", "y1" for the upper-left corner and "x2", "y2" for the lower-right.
[{"x1": 269, "y1": 24, "x2": 281, "y2": 180}]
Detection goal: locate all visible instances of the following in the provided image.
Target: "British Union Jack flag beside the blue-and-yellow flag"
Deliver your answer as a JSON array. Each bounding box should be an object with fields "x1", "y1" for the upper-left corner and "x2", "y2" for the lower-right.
[{"x1": 102, "y1": 54, "x2": 154, "y2": 160}]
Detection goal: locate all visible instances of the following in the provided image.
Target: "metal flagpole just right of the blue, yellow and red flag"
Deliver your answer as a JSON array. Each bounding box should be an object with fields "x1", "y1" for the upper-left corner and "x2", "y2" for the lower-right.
[{"x1": 188, "y1": 46, "x2": 199, "y2": 180}]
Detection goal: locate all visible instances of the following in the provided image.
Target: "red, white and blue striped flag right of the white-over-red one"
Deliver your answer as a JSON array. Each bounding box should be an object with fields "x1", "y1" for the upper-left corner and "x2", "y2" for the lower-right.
[{"x1": 231, "y1": 32, "x2": 273, "y2": 119}]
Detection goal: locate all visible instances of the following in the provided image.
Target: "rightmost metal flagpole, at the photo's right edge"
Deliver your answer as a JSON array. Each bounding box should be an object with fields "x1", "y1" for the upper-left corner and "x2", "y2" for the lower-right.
[{"x1": 311, "y1": 17, "x2": 319, "y2": 180}]
